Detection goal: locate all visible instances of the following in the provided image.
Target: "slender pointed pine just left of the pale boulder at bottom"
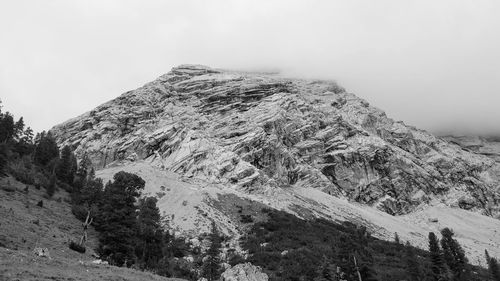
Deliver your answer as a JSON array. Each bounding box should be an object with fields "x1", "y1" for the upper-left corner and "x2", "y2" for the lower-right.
[{"x1": 203, "y1": 223, "x2": 222, "y2": 281}]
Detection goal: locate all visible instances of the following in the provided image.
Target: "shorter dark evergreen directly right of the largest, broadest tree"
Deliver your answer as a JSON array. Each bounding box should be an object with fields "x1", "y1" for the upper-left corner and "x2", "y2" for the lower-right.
[{"x1": 135, "y1": 197, "x2": 163, "y2": 269}]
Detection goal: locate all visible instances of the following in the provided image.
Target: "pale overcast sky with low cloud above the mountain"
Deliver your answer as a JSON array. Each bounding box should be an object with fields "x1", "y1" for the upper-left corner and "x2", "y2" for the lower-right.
[{"x1": 0, "y1": 0, "x2": 500, "y2": 134}]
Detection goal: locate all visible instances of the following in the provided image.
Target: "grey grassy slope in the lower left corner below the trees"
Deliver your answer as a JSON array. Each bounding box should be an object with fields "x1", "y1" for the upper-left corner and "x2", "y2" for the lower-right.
[{"x1": 0, "y1": 178, "x2": 185, "y2": 280}]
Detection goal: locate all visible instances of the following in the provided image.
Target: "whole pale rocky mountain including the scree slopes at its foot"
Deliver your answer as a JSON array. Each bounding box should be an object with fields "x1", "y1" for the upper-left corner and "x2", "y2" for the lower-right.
[{"x1": 52, "y1": 65, "x2": 500, "y2": 262}]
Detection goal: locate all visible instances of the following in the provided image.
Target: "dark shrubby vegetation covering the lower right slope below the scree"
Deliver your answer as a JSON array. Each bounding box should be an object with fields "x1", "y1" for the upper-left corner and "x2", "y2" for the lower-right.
[{"x1": 242, "y1": 209, "x2": 488, "y2": 281}]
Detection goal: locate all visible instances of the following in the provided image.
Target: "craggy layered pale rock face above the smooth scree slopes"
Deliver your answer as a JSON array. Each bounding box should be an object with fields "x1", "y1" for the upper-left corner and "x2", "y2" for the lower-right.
[{"x1": 52, "y1": 65, "x2": 500, "y2": 217}]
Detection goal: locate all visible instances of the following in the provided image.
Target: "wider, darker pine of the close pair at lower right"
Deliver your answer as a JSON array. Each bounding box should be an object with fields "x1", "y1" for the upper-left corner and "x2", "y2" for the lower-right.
[{"x1": 441, "y1": 228, "x2": 469, "y2": 281}]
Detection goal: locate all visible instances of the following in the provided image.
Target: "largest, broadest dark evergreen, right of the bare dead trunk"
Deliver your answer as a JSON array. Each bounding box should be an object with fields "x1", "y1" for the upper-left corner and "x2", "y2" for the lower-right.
[{"x1": 96, "y1": 171, "x2": 145, "y2": 266}]
